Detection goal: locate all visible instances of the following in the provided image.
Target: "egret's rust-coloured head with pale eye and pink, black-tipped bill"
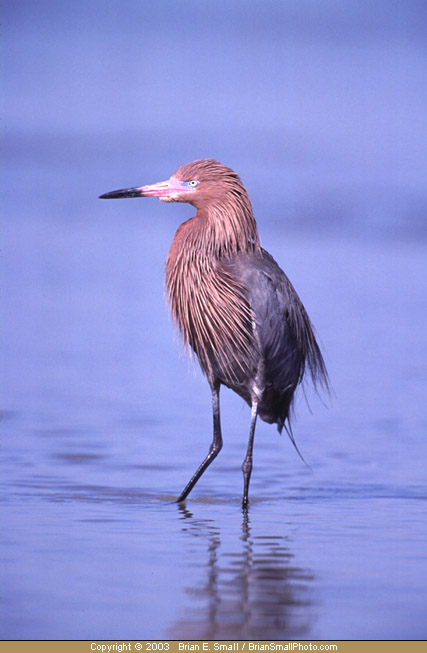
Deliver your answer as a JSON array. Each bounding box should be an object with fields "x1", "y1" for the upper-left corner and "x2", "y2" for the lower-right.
[{"x1": 100, "y1": 159, "x2": 247, "y2": 209}]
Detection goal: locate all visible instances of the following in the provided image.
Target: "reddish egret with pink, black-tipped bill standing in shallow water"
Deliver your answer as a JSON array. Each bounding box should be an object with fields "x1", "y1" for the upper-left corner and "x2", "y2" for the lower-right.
[{"x1": 101, "y1": 159, "x2": 328, "y2": 507}]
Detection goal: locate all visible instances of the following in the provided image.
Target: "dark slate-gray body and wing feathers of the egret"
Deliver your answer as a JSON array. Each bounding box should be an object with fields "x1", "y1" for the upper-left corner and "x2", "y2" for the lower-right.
[{"x1": 206, "y1": 250, "x2": 328, "y2": 431}]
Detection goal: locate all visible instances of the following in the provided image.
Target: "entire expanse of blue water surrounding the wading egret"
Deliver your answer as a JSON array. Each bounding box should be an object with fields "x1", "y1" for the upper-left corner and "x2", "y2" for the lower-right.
[{"x1": 0, "y1": 0, "x2": 427, "y2": 639}]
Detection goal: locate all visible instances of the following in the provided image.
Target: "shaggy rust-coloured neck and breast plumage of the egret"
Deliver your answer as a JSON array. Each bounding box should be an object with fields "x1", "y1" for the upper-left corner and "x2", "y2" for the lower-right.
[{"x1": 166, "y1": 188, "x2": 261, "y2": 376}]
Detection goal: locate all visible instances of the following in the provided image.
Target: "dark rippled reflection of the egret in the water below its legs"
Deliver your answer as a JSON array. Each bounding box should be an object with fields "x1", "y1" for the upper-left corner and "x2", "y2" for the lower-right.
[{"x1": 170, "y1": 507, "x2": 314, "y2": 640}]
